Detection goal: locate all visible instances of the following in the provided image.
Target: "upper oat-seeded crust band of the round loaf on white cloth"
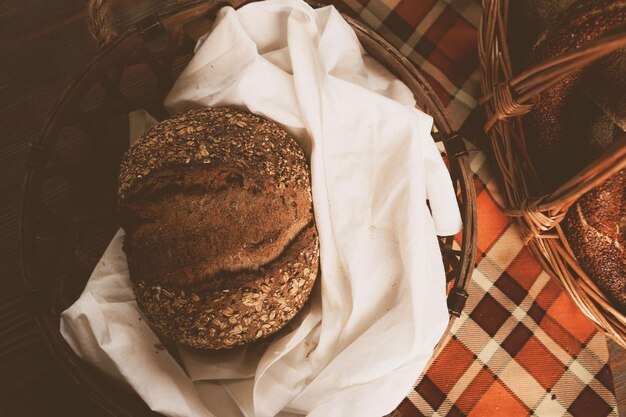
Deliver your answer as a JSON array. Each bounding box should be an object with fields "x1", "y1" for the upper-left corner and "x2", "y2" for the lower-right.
[{"x1": 118, "y1": 107, "x2": 310, "y2": 201}]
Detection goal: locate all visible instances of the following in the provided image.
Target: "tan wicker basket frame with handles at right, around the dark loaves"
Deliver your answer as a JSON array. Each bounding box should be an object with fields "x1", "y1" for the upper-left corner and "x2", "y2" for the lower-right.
[{"x1": 479, "y1": 0, "x2": 626, "y2": 347}]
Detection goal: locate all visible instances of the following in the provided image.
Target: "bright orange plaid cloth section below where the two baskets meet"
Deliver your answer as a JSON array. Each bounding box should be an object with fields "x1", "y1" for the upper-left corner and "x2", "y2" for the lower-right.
[{"x1": 397, "y1": 143, "x2": 617, "y2": 417}]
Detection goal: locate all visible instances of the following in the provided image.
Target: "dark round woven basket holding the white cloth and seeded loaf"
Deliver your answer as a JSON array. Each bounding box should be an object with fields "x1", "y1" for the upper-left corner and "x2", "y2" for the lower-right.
[{"x1": 20, "y1": 0, "x2": 476, "y2": 416}]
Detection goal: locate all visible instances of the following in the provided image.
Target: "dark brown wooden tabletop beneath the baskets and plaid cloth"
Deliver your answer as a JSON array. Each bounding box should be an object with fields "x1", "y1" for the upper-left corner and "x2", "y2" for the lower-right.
[{"x1": 0, "y1": 0, "x2": 626, "y2": 417}]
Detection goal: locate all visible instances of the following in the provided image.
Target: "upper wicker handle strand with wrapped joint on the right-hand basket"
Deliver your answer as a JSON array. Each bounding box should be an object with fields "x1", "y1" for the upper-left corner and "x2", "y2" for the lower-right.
[{"x1": 479, "y1": 31, "x2": 626, "y2": 133}]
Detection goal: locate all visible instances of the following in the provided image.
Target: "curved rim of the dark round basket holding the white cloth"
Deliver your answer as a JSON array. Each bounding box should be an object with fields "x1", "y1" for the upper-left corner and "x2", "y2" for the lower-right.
[{"x1": 19, "y1": 0, "x2": 477, "y2": 417}]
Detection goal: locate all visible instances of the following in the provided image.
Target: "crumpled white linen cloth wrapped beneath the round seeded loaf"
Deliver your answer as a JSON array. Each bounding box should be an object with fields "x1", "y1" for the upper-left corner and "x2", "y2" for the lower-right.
[{"x1": 61, "y1": 0, "x2": 461, "y2": 417}]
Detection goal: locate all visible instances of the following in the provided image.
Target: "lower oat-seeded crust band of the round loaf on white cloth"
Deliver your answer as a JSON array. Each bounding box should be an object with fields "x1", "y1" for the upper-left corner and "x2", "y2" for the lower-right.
[{"x1": 133, "y1": 224, "x2": 319, "y2": 349}]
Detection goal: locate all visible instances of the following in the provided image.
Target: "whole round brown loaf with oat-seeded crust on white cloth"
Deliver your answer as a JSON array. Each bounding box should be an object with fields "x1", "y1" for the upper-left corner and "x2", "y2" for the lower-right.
[{"x1": 118, "y1": 107, "x2": 319, "y2": 349}]
